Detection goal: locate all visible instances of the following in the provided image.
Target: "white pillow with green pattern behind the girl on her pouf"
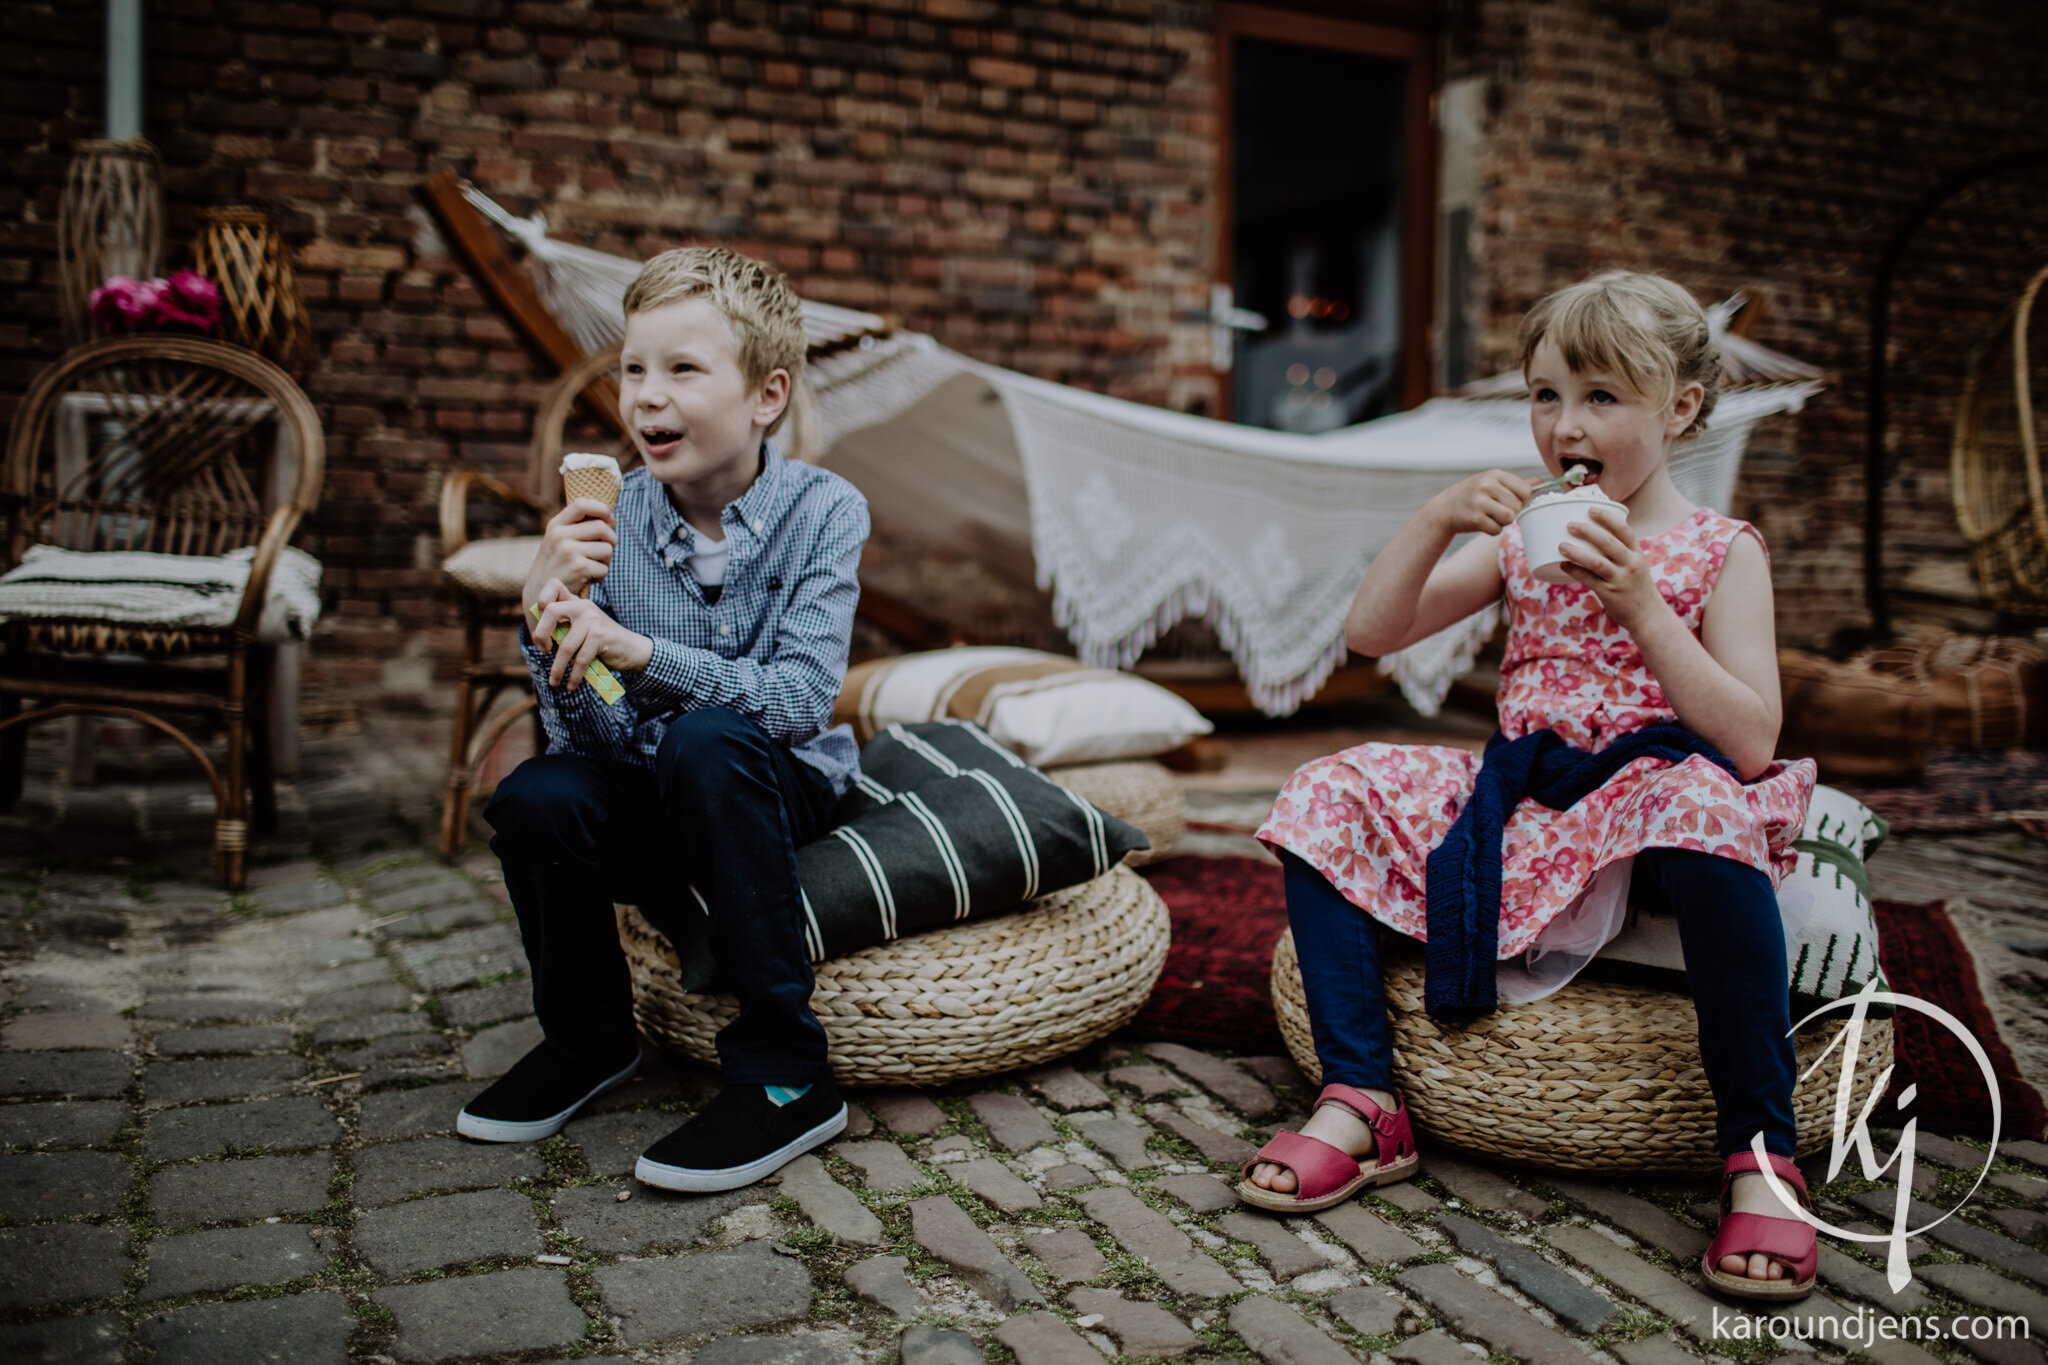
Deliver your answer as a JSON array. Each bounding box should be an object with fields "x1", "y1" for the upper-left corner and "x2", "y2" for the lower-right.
[{"x1": 1593, "y1": 786, "x2": 1890, "y2": 1017}]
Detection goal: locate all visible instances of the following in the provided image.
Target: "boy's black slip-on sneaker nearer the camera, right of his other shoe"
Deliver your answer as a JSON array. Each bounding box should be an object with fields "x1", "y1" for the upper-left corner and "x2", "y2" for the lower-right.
[{"x1": 633, "y1": 1081, "x2": 846, "y2": 1193}]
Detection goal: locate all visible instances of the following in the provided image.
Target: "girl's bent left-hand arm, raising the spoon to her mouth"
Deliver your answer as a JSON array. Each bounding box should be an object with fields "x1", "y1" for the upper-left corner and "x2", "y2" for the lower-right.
[{"x1": 1343, "y1": 469, "x2": 1530, "y2": 657}]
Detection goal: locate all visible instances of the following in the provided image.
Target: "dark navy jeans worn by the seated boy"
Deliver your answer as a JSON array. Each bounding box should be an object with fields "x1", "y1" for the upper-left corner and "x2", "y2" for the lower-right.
[{"x1": 483, "y1": 708, "x2": 834, "y2": 1085}]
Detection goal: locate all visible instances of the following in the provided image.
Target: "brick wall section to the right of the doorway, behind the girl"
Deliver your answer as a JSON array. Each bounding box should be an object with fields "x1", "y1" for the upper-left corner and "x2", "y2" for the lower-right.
[{"x1": 1448, "y1": 0, "x2": 2048, "y2": 645}]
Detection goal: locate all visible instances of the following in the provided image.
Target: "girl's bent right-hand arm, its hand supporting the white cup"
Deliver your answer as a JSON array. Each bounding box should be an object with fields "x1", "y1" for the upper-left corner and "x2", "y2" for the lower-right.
[{"x1": 1565, "y1": 512, "x2": 1782, "y2": 782}]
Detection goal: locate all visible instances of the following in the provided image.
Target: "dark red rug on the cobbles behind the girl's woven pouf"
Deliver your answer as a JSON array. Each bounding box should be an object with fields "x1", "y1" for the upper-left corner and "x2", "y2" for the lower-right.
[{"x1": 1126, "y1": 857, "x2": 2048, "y2": 1138}]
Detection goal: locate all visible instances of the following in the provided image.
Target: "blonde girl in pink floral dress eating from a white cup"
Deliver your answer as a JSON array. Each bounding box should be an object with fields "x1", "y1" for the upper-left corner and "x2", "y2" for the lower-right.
[{"x1": 1239, "y1": 274, "x2": 1819, "y2": 1297}]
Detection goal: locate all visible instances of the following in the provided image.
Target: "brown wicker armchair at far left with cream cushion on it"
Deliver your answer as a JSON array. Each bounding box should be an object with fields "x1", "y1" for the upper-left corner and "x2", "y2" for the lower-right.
[{"x1": 0, "y1": 336, "x2": 326, "y2": 888}]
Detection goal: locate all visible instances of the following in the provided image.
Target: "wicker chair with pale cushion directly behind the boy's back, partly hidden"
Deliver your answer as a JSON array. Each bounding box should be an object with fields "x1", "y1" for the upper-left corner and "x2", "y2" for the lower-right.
[{"x1": 440, "y1": 346, "x2": 639, "y2": 853}]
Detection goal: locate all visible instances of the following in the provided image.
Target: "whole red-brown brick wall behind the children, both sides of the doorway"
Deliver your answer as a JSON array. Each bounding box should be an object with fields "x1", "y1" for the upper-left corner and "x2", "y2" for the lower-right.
[{"x1": 0, "y1": 0, "x2": 2048, "y2": 703}]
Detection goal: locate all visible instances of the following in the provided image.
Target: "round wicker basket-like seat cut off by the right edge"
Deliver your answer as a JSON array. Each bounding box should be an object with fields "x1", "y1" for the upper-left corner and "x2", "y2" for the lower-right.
[{"x1": 1950, "y1": 268, "x2": 2048, "y2": 616}]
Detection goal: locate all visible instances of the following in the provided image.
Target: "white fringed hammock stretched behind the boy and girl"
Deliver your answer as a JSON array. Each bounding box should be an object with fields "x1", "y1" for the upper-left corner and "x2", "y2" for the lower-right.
[{"x1": 456, "y1": 190, "x2": 1821, "y2": 714}]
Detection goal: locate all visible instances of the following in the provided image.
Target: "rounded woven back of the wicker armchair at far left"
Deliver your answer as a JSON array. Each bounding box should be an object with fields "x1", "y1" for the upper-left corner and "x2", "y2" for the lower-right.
[{"x1": 0, "y1": 336, "x2": 326, "y2": 567}]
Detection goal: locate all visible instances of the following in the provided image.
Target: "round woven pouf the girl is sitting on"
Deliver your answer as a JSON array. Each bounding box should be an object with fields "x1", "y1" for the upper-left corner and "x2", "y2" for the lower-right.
[{"x1": 1272, "y1": 931, "x2": 1892, "y2": 1175}]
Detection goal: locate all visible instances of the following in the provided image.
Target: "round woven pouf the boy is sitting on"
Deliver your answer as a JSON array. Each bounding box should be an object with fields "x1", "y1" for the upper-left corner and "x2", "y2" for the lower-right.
[{"x1": 618, "y1": 868, "x2": 1171, "y2": 1085}]
